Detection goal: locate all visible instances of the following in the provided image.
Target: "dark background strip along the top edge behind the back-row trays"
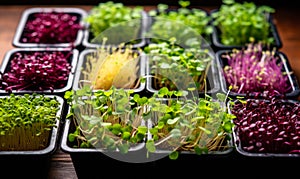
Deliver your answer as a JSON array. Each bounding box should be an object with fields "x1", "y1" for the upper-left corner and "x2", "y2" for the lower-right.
[{"x1": 0, "y1": 0, "x2": 297, "y2": 7}]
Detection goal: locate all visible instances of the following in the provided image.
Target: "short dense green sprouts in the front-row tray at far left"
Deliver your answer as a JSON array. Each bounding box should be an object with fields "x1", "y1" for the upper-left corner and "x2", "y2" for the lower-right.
[{"x1": 0, "y1": 93, "x2": 60, "y2": 151}]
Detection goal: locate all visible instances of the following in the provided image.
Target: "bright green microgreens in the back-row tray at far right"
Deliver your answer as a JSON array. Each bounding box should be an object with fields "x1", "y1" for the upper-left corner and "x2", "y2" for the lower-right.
[{"x1": 211, "y1": 0, "x2": 275, "y2": 45}]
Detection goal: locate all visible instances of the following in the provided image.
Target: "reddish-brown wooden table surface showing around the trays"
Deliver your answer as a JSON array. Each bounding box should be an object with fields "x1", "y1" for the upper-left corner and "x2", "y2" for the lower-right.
[{"x1": 0, "y1": 5, "x2": 300, "y2": 179}]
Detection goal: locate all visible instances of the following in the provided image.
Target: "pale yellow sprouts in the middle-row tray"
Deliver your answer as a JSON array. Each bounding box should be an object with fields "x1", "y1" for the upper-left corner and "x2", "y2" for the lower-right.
[{"x1": 81, "y1": 38, "x2": 140, "y2": 90}]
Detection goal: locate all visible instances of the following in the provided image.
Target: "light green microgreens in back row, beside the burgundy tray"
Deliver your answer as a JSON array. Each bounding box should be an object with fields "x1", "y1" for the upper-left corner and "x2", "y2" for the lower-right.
[{"x1": 84, "y1": 1, "x2": 143, "y2": 44}]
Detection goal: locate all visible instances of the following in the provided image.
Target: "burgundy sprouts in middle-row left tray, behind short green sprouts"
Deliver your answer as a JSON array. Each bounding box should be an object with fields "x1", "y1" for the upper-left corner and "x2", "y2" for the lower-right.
[{"x1": 0, "y1": 51, "x2": 72, "y2": 91}]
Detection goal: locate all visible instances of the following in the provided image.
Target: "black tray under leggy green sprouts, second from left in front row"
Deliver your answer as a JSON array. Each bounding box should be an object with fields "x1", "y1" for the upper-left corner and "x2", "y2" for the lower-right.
[{"x1": 60, "y1": 106, "x2": 150, "y2": 178}]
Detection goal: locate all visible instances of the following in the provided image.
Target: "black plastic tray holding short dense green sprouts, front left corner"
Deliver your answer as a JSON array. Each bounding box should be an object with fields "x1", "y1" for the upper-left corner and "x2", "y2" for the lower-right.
[{"x1": 0, "y1": 95, "x2": 65, "y2": 179}]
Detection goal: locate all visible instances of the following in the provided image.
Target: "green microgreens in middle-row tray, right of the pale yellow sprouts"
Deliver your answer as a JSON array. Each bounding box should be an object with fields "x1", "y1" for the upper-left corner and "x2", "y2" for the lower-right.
[{"x1": 144, "y1": 38, "x2": 213, "y2": 91}]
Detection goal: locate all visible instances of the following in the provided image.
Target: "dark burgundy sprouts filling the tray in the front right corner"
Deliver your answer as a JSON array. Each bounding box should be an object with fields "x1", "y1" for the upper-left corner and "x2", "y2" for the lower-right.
[{"x1": 231, "y1": 92, "x2": 300, "y2": 154}]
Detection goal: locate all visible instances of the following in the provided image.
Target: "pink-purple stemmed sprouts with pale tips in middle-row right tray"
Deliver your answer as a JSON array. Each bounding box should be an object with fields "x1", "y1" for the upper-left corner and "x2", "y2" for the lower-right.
[{"x1": 222, "y1": 43, "x2": 291, "y2": 94}]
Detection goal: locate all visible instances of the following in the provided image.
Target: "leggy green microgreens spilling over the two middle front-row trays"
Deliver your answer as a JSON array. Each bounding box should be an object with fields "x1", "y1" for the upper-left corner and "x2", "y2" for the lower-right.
[{"x1": 65, "y1": 86, "x2": 235, "y2": 159}]
